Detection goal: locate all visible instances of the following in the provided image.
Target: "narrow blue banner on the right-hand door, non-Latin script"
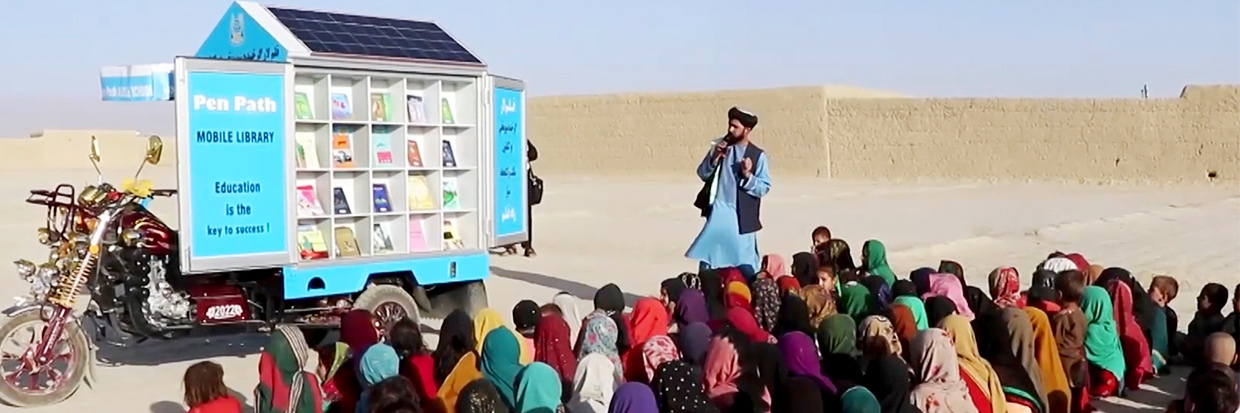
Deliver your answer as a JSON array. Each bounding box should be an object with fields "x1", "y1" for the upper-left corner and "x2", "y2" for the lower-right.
[{"x1": 494, "y1": 87, "x2": 527, "y2": 237}]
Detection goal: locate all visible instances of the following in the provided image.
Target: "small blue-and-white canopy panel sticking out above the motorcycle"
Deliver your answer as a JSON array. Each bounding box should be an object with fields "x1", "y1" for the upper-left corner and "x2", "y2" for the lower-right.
[{"x1": 99, "y1": 63, "x2": 172, "y2": 102}]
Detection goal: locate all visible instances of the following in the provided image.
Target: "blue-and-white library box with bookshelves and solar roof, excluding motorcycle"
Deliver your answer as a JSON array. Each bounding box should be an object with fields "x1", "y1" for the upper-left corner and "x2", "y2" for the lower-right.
[{"x1": 175, "y1": 1, "x2": 528, "y2": 316}]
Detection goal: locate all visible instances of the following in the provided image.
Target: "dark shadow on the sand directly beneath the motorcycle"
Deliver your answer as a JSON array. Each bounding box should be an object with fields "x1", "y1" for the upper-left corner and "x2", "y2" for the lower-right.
[{"x1": 97, "y1": 334, "x2": 268, "y2": 366}]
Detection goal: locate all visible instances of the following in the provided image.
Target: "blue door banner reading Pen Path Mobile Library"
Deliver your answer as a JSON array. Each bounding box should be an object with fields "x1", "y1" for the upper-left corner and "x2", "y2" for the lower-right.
[{"x1": 177, "y1": 72, "x2": 289, "y2": 258}]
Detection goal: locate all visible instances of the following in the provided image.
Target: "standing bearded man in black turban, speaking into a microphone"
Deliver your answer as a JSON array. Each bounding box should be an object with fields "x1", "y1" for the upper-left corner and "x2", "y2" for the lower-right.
[{"x1": 684, "y1": 108, "x2": 771, "y2": 277}]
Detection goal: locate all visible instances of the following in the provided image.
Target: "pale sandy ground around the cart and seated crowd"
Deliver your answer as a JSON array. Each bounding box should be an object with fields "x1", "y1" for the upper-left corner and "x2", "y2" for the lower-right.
[{"x1": 0, "y1": 171, "x2": 1240, "y2": 413}]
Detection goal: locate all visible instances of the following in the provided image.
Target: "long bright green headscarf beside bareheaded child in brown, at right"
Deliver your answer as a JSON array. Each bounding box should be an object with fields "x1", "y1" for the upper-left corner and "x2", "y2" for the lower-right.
[{"x1": 1081, "y1": 285, "x2": 1125, "y2": 378}]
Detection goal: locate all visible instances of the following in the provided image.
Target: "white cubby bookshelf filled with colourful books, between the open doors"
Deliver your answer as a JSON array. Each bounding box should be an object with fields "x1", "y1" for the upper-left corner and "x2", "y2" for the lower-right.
[{"x1": 294, "y1": 71, "x2": 484, "y2": 262}]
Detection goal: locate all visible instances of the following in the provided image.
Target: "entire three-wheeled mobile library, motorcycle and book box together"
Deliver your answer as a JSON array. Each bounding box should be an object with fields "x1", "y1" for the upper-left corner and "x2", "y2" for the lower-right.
[{"x1": 0, "y1": 1, "x2": 528, "y2": 407}]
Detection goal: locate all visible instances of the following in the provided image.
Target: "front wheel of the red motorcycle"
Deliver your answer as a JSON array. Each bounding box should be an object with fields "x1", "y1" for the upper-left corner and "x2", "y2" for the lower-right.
[{"x1": 0, "y1": 311, "x2": 93, "y2": 407}]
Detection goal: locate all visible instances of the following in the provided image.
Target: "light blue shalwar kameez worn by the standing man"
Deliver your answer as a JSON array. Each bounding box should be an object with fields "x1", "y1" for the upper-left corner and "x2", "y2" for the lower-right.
[{"x1": 684, "y1": 144, "x2": 771, "y2": 270}]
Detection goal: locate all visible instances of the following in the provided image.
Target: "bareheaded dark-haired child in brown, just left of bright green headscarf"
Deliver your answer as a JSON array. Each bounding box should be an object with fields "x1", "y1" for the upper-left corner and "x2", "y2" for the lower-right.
[{"x1": 1050, "y1": 272, "x2": 1090, "y2": 412}]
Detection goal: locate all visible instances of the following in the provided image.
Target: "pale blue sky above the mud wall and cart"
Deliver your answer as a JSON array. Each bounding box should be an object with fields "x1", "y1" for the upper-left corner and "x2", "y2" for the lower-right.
[{"x1": 0, "y1": 0, "x2": 1240, "y2": 136}]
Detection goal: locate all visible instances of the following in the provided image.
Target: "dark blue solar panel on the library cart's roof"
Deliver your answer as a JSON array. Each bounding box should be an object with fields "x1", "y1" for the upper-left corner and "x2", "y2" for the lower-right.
[{"x1": 267, "y1": 7, "x2": 482, "y2": 64}]
